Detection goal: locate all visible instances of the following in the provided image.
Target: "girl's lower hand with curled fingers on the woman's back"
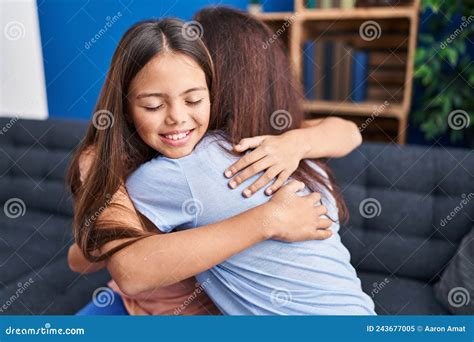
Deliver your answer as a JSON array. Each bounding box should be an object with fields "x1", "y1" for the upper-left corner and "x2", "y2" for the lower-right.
[{"x1": 263, "y1": 181, "x2": 332, "y2": 242}]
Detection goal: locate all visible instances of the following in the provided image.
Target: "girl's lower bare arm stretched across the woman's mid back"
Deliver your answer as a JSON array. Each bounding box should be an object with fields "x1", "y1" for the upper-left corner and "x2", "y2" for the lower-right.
[{"x1": 69, "y1": 151, "x2": 332, "y2": 296}]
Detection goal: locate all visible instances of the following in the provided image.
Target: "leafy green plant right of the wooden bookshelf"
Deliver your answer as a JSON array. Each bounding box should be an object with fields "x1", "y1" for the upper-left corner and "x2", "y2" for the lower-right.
[{"x1": 412, "y1": 0, "x2": 474, "y2": 142}]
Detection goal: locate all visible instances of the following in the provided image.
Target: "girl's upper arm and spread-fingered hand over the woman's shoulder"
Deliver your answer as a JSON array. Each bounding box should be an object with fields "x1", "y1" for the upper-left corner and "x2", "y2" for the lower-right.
[{"x1": 225, "y1": 117, "x2": 362, "y2": 197}]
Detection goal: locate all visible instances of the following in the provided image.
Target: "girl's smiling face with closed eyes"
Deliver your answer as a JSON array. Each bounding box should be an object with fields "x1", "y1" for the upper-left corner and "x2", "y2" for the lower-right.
[{"x1": 128, "y1": 52, "x2": 210, "y2": 158}]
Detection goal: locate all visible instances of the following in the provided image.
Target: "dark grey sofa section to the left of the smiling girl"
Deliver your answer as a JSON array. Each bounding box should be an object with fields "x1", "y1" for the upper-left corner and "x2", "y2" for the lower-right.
[{"x1": 0, "y1": 118, "x2": 110, "y2": 314}]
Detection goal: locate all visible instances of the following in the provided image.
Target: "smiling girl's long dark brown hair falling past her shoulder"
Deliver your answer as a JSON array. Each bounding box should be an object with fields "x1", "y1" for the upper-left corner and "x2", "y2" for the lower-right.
[{"x1": 67, "y1": 19, "x2": 214, "y2": 261}]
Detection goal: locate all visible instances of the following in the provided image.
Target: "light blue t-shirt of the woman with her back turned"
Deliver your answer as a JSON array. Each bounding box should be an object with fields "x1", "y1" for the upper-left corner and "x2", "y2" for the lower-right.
[{"x1": 127, "y1": 134, "x2": 375, "y2": 315}]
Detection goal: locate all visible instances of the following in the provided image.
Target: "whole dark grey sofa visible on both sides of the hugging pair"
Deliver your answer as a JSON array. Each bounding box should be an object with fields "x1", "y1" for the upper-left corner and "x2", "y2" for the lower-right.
[{"x1": 0, "y1": 118, "x2": 474, "y2": 315}]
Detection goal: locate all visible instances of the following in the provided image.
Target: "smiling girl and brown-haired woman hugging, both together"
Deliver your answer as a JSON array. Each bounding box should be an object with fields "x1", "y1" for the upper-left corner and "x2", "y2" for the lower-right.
[{"x1": 67, "y1": 7, "x2": 375, "y2": 315}]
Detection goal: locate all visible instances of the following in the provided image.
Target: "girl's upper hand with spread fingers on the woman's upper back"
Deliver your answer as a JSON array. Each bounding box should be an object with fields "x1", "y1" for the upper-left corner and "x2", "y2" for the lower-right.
[{"x1": 224, "y1": 130, "x2": 307, "y2": 197}]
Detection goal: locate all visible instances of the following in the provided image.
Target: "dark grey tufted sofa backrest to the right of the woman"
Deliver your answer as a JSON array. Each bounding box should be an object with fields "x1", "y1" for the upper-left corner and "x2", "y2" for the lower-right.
[{"x1": 330, "y1": 144, "x2": 474, "y2": 282}]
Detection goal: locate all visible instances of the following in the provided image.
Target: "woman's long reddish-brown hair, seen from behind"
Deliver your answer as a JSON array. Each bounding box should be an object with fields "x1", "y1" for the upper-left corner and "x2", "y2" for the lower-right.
[{"x1": 194, "y1": 7, "x2": 348, "y2": 222}]
